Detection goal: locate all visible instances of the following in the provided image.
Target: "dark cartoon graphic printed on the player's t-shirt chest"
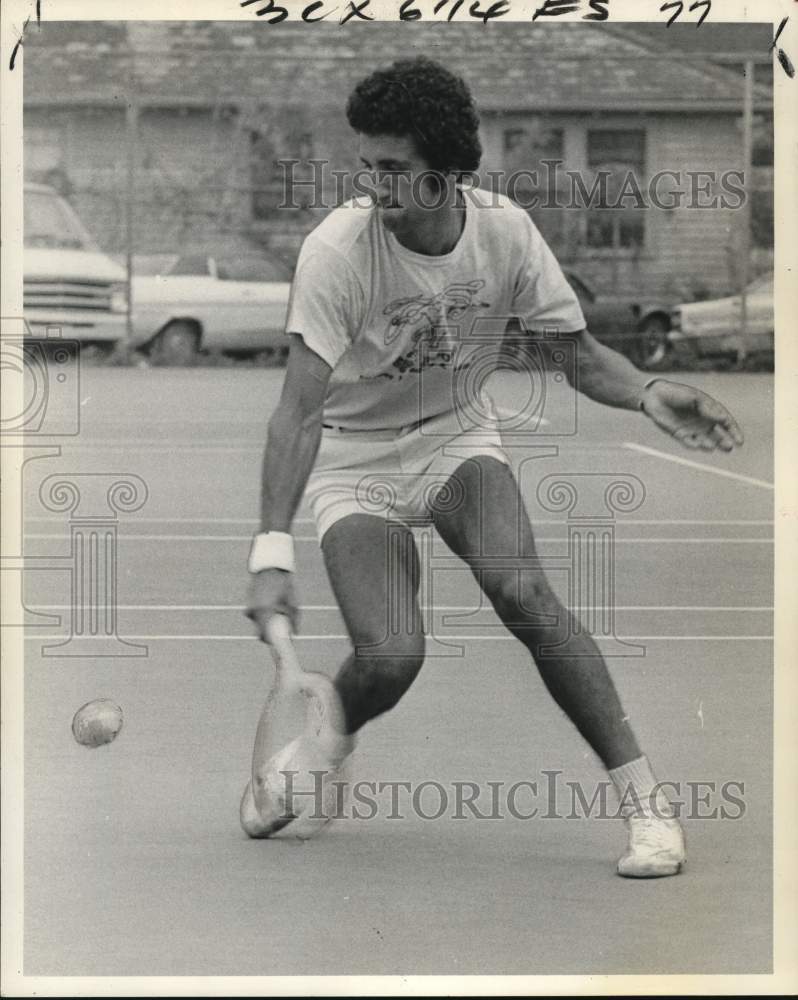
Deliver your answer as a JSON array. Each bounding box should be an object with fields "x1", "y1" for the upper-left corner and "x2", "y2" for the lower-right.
[{"x1": 377, "y1": 278, "x2": 490, "y2": 379}]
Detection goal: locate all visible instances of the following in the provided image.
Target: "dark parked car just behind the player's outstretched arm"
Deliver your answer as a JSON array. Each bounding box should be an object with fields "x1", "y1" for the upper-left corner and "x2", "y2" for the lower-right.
[{"x1": 564, "y1": 268, "x2": 671, "y2": 369}]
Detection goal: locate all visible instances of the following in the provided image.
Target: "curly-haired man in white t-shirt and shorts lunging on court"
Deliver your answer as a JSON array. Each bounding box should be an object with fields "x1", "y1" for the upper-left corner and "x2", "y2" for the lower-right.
[{"x1": 247, "y1": 58, "x2": 743, "y2": 878}]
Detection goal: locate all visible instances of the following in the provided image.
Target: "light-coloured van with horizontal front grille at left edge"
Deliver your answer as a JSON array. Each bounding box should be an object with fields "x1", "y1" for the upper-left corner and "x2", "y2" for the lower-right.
[{"x1": 23, "y1": 183, "x2": 127, "y2": 350}]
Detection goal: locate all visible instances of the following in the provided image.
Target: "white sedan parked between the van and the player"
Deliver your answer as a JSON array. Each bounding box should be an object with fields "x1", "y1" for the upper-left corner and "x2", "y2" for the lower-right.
[{"x1": 132, "y1": 251, "x2": 291, "y2": 365}]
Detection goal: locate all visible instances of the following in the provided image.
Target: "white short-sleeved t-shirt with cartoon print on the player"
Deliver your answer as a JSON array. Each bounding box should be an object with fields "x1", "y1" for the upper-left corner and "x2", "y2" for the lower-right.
[{"x1": 286, "y1": 189, "x2": 585, "y2": 430}]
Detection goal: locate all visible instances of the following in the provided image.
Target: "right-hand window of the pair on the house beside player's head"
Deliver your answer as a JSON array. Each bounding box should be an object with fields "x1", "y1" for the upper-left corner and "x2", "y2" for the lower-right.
[{"x1": 587, "y1": 129, "x2": 646, "y2": 250}]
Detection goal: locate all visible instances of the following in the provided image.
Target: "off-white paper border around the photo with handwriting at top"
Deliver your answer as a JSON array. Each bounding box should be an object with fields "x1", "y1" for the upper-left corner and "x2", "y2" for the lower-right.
[{"x1": 0, "y1": 0, "x2": 798, "y2": 996}]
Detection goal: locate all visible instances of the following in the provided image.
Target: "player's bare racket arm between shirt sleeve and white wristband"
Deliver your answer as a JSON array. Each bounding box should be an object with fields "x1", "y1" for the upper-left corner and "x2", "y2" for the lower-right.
[{"x1": 260, "y1": 334, "x2": 332, "y2": 532}]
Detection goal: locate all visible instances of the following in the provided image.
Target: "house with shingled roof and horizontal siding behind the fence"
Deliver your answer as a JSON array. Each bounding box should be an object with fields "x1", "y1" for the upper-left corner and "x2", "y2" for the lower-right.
[{"x1": 24, "y1": 19, "x2": 772, "y2": 299}]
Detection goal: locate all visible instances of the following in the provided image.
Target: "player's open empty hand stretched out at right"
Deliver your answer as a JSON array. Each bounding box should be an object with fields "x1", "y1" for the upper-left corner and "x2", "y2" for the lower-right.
[{"x1": 643, "y1": 379, "x2": 744, "y2": 451}]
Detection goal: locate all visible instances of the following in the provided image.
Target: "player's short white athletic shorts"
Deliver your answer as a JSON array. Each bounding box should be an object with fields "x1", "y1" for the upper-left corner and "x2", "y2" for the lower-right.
[{"x1": 305, "y1": 413, "x2": 511, "y2": 542}]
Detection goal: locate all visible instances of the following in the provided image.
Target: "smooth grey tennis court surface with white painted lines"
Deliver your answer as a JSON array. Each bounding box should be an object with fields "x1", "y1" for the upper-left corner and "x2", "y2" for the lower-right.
[{"x1": 24, "y1": 368, "x2": 773, "y2": 976}]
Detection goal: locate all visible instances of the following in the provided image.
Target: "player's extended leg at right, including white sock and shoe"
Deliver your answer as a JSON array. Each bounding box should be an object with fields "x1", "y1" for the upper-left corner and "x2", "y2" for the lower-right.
[{"x1": 435, "y1": 456, "x2": 684, "y2": 878}]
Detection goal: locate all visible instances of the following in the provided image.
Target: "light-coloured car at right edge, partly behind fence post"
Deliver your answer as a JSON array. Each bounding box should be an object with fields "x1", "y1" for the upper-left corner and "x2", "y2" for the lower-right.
[{"x1": 668, "y1": 274, "x2": 775, "y2": 362}]
